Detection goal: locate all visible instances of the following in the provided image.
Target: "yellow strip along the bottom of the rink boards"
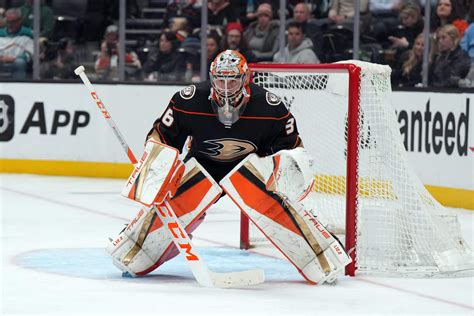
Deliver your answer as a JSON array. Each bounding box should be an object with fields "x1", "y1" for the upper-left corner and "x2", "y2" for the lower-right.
[{"x1": 0, "y1": 159, "x2": 474, "y2": 210}]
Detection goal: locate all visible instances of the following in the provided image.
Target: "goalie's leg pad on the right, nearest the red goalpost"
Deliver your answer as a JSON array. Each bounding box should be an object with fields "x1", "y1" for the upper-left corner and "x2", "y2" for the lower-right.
[{"x1": 220, "y1": 155, "x2": 351, "y2": 284}]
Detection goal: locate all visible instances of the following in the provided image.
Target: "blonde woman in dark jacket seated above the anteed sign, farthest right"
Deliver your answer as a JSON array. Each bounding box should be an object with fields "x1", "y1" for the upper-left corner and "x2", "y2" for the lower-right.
[{"x1": 430, "y1": 24, "x2": 471, "y2": 87}]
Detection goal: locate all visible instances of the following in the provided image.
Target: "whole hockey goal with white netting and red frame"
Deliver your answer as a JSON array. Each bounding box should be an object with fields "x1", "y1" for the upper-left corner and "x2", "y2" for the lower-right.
[{"x1": 241, "y1": 61, "x2": 474, "y2": 276}]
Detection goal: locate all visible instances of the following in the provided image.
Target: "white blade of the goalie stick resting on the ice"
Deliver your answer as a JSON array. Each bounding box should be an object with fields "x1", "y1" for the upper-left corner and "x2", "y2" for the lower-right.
[{"x1": 210, "y1": 269, "x2": 265, "y2": 289}]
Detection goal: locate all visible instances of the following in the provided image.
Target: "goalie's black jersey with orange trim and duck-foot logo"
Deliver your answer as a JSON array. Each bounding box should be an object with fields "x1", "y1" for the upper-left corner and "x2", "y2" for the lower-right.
[{"x1": 148, "y1": 81, "x2": 301, "y2": 181}]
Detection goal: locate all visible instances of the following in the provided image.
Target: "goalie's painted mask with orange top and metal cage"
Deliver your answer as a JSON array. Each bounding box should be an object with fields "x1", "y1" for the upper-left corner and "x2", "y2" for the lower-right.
[{"x1": 209, "y1": 49, "x2": 250, "y2": 128}]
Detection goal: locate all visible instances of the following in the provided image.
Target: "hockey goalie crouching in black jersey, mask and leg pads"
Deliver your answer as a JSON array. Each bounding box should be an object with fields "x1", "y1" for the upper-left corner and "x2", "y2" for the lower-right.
[{"x1": 107, "y1": 50, "x2": 351, "y2": 284}]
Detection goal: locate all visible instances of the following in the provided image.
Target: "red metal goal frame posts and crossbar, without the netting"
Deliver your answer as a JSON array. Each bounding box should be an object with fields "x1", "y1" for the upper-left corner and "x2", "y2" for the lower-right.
[{"x1": 240, "y1": 63, "x2": 361, "y2": 276}]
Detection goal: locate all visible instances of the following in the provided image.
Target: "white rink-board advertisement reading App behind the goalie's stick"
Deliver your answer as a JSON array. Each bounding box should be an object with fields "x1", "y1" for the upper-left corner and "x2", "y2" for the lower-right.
[{"x1": 0, "y1": 83, "x2": 179, "y2": 162}]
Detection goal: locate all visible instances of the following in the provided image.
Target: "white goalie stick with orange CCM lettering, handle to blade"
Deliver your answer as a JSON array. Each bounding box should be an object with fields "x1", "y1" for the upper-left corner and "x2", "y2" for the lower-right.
[{"x1": 74, "y1": 66, "x2": 265, "y2": 288}]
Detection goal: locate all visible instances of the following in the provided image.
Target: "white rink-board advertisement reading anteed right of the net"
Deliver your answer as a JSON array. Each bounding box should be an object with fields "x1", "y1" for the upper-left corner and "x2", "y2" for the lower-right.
[{"x1": 392, "y1": 91, "x2": 474, "y2": 190}]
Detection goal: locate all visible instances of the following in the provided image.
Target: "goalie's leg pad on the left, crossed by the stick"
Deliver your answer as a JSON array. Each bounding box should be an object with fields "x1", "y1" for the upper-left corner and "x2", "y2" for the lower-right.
[{"x1": 106, "y1": 159, "x2": 222, "y2": 276}]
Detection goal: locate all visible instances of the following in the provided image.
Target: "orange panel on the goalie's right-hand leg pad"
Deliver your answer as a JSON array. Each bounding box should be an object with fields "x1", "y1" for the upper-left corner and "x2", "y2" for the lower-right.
[{"x1": 230, "y1": 172, "x2": 301, "y2": 236}]
